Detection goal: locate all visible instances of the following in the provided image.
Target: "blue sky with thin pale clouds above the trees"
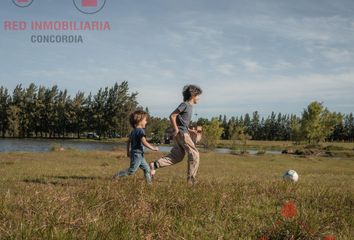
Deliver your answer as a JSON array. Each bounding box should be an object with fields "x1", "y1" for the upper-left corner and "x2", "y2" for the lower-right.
[{"x1": 0, "y1": 0, "x2": 354, "y2": 118}]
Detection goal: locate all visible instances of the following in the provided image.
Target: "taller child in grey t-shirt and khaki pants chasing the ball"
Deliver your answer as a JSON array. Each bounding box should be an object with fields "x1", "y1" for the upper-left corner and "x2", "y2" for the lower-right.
[{"x1": 150, "y1": 85, "x2": 202, "y2": 184}]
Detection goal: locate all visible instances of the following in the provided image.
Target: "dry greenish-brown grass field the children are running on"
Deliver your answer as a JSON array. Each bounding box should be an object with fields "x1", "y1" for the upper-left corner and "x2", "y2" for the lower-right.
[{"x1": 0, "y1": 151, "x2": 354, "y2": 239}]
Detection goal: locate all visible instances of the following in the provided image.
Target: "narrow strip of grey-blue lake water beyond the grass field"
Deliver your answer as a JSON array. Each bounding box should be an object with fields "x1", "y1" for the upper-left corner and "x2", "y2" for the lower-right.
[{"x1": 0, "y1": 138, "x2": 281, "y2": 154}]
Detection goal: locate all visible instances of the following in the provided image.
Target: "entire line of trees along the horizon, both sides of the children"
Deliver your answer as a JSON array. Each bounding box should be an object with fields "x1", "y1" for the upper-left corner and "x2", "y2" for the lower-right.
[{"x1": 0, "y1": 82, "x2": 354, "y2": 142}]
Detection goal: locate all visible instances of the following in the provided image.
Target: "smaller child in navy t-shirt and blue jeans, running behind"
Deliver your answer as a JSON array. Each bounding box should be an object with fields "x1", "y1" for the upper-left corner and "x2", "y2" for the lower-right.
[{"x1": 113, "y1": 110, "x2": 159, "y2": 183}]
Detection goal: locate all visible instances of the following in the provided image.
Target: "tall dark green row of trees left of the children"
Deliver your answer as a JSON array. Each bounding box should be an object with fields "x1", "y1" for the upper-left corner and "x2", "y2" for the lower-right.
[{"x1": 0, "y1": 82, "x2": 139, "y2": 138}]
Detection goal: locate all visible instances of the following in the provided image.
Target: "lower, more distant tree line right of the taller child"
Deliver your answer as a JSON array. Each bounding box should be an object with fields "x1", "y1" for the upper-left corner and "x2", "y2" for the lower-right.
[{"x1": 198, "y1": 102, "x2": 354, "y2": 143}]
